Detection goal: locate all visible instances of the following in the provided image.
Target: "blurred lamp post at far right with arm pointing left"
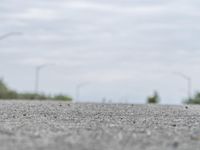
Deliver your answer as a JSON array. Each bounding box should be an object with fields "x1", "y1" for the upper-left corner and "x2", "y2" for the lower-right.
[{"x1": 173, "y1": 72, "x2": 192, "y2": 100}]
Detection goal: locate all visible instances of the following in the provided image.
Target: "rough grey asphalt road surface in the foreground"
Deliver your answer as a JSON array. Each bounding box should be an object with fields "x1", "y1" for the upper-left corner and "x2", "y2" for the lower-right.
[{"x1": 0, "y1": 101, "x2": 200, "y2": 150}]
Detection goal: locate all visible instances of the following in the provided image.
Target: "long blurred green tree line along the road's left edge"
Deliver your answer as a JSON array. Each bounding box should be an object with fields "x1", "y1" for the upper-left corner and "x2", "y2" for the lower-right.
[{"x1": 0, "y1": 79, "x2": 72, "y2": 101}]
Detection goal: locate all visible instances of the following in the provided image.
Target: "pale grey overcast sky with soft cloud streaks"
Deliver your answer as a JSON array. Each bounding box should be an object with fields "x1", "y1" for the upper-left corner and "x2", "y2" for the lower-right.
[{"x1": 0, "y1": 0, "x2": 200, "y2": 104}]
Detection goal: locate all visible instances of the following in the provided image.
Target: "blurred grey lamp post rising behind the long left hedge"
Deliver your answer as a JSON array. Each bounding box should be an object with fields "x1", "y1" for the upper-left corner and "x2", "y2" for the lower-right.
[{"x1": 35, "y1": 64, "x2": 51, "y2": 94}]
